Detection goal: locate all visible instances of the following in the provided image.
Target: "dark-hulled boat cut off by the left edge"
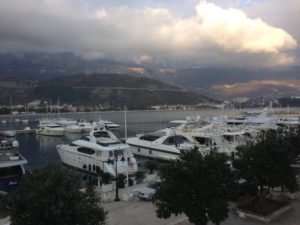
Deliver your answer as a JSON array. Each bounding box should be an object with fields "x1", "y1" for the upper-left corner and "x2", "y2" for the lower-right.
[{"x1": 0, "y1": 139, "x2": 27, "y2": 192}]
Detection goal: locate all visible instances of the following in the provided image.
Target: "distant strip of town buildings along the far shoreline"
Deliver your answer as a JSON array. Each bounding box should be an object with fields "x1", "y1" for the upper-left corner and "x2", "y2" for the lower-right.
[{"x1": 0, "y1": 96, "x2": 300, "y2": 115}]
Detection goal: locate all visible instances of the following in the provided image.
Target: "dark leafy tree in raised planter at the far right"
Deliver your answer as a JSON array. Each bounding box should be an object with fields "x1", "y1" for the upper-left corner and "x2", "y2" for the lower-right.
[{"x1": 233, "y1": 130, "x2": 297, "y2": 200}]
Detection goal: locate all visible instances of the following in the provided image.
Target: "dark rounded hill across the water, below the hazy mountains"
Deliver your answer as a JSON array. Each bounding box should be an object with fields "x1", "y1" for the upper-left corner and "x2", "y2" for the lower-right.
[{"x1": 0, "y1": 74, "x2": 212, "y2": 109}]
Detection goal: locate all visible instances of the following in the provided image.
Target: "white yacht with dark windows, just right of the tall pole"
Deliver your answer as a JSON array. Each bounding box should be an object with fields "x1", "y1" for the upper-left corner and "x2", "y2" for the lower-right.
[{"x1": 127, "y1": 128, "x2": 194, "y2": 160}]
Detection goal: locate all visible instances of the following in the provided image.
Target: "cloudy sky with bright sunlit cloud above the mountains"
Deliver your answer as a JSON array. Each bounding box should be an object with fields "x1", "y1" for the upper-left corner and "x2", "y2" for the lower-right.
[{"x1": 0, "y1": 0, "x2": 300, "y2": 68}]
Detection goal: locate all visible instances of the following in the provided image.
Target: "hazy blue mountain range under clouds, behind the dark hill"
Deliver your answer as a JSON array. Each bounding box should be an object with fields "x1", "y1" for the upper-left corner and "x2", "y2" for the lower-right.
[{"x1": 0, "y1": 52, "x2": 300, "y2": 100}]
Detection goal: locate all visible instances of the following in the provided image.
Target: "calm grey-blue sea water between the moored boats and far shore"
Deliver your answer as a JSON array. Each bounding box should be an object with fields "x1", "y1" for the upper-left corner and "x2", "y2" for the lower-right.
[{"x1": 0, "y1": 109, "x2": 300, "y2": 169}]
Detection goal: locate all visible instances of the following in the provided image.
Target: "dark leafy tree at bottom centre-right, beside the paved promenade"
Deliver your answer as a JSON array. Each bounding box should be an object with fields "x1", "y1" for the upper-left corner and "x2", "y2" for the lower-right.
[{"x1": 153, "y1": 149, "x2": 234, "y2": 225}]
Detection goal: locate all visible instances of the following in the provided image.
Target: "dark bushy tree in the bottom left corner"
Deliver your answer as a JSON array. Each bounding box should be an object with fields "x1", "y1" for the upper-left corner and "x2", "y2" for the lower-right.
[{"x1": 2, "y1": 165, "x2": 105, "y2": 225}]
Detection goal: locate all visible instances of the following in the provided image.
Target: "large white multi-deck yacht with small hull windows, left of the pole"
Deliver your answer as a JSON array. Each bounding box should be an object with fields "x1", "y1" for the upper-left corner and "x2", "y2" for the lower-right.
[{"x1": 57, "y1": 127, "x2": 137, "y2": 176}]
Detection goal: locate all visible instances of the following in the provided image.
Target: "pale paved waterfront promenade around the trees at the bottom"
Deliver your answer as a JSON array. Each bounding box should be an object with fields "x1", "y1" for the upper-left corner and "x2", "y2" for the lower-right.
[{"x1": 0, "y1": 184, "x2": 300, "y2": 225}]
